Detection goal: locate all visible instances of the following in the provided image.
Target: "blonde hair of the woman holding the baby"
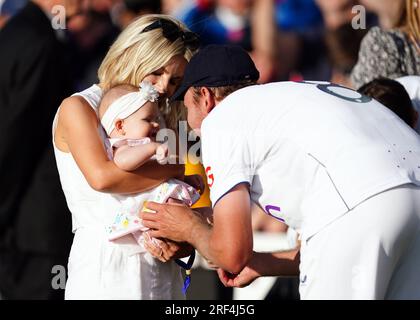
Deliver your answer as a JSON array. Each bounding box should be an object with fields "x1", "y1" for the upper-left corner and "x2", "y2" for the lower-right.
[{"x1": 98, "y1": 14, "x2": 194, "y2": 129}]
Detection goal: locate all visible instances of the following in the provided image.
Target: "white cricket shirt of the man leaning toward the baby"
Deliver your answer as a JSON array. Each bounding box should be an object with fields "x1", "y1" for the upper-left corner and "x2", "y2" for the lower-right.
[{"x1": 201, "y1": 82, "x2": 420, "y2": 239}]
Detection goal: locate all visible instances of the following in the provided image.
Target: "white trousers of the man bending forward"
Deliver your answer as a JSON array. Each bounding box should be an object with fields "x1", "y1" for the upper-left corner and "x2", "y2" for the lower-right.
[{"x1": 299, "y1": 185, "x2": 420, "y2": 299}]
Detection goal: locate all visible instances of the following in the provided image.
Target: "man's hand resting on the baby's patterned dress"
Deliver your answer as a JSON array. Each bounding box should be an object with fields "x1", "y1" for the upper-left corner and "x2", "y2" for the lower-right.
[{"x1": 140, "y1": 202, "x2": 201, "y2": 243}]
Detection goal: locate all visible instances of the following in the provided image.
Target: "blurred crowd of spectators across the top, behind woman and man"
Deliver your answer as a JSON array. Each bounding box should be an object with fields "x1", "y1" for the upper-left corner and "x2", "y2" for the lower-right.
[{"x1": 0, "y1": 0, "x2": 394, "y2": 88}]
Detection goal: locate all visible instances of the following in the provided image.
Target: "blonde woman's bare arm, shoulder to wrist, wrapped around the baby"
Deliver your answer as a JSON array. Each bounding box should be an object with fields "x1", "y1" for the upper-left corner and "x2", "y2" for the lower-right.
[{"x1": 56, "y1": 97, "x2": 184, "y2": 193}]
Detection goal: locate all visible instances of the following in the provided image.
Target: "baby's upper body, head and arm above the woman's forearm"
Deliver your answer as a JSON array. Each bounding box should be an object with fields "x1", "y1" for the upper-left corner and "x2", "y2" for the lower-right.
[{"x1": 99, "y1": 83, "x2": 168, "y2": 171}]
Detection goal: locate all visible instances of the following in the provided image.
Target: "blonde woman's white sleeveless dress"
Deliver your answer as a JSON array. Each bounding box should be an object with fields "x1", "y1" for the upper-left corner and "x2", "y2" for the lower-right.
[{"x1": 53, "y1": 85, "x2": 184, "y2": 299}]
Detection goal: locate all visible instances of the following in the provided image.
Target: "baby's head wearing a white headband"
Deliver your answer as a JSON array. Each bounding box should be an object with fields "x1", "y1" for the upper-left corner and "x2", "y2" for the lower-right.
[{"x1": 99, "y1": 83, "x2": 159, "y2": 139}]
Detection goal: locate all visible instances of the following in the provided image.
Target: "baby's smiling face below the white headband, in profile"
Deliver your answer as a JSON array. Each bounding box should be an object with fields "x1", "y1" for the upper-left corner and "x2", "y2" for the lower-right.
[{"x1": 123, "y1": 101, "x2": 159, "y2": 139}]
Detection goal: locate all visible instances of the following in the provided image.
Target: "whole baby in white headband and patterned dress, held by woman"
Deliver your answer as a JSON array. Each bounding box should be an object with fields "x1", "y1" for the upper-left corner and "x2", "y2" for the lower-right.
[{"x1": 99, "y1": 82, "x2": 200, "y2": 251}]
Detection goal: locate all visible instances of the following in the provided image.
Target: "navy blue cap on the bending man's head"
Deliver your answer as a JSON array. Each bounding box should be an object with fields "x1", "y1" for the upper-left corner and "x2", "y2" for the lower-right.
[{"x1": 170, "y1": 45, "x2": 260, "y2": 101}]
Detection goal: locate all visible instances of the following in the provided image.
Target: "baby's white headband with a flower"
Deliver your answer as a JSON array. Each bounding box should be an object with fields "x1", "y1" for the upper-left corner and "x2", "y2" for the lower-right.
[{"x1": 101, "y1": 81, "x2": 159, "y2": 136}]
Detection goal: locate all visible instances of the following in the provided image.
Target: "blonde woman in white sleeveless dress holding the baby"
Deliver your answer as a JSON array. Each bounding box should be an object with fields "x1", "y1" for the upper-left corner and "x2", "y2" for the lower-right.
[{"x1": 53, "y1": 15, "x2": 198, "y2": 299}]
